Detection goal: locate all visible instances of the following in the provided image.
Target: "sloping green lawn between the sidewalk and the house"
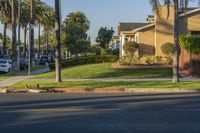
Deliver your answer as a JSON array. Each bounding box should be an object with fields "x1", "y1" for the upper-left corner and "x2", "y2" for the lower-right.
[{"x1": 35, "y1": 63, "x2": 172, "y2": 78}]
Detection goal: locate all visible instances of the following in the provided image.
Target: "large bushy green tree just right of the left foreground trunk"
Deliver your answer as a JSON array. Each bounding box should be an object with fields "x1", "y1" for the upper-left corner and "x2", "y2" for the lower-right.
[{"x1": 64, "y1": 12, "x2": 90, "y2": 57}]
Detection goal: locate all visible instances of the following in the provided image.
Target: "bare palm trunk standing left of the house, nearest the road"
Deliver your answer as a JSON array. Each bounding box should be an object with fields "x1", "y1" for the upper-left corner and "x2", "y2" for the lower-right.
[{"x1": 55, "y1": 0, "x2": 62, "y2": 82}]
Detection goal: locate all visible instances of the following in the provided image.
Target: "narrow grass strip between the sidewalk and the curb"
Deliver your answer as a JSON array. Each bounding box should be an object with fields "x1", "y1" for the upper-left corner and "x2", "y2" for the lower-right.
[{"x1": 10, "y1": 80, "x2": 200, "y2": 89}]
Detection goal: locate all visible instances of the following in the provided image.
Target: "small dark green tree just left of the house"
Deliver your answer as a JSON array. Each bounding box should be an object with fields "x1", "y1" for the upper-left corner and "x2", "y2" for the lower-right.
[{"x1": 96, "y1": 27, "x2": 114, "y2": 50}]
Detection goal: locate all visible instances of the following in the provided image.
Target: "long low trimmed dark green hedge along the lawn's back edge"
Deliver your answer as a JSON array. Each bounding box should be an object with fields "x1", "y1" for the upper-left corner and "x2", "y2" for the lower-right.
[{"x1": 49, "y1": 55, "x2": 118, "y2": 69}]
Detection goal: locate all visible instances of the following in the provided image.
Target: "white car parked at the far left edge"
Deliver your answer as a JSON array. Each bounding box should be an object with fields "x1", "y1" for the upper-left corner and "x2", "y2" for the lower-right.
[{"x1": 0, "y1": 60, "x2": 12, "y2": 73}]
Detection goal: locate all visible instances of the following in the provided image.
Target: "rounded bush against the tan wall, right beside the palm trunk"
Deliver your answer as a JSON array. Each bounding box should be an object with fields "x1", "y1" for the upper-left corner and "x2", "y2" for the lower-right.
[{"x1": 161, "y1": 42, "x2": 174, "y2": 56}]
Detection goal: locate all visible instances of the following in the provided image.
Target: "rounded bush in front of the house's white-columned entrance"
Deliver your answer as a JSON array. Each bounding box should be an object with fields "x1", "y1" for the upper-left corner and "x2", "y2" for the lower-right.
[{"x1": 123, "y1": 42, "x2": 139, "y2": 55}]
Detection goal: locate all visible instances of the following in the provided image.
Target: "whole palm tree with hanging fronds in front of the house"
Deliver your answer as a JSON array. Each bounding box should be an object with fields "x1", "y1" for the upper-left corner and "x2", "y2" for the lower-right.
[{"x1": 150, "y1": 0, "x2": 190, "y2": 82}]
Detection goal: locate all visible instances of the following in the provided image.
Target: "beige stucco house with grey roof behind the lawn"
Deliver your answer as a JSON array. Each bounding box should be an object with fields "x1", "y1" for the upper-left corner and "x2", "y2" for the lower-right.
[{"x1": 118, "y1": 6, "x2": 200, "y2": 57}]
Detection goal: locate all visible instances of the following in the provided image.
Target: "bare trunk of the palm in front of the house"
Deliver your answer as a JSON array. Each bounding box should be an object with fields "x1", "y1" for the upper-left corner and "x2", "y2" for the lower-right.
[{"x1": 173, "y1": 0, "x2": 179, "y2": 82}]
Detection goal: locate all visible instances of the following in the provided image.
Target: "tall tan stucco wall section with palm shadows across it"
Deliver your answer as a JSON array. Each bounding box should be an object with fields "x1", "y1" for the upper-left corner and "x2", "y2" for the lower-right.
[{"x1": 155, "y1": 6, "x2": 174, "y2": 56}]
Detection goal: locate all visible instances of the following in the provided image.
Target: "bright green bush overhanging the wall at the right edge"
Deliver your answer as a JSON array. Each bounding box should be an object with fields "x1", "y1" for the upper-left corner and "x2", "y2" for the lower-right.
[{"x1": 179, "y1": 35, "x2": 200, "y2": 55}]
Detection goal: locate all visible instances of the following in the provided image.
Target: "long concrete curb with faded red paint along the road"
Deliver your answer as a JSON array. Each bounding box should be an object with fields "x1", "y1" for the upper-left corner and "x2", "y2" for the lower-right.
[{"x1": 0, "y1": 88, "x2": 200, "y2": 94}]
